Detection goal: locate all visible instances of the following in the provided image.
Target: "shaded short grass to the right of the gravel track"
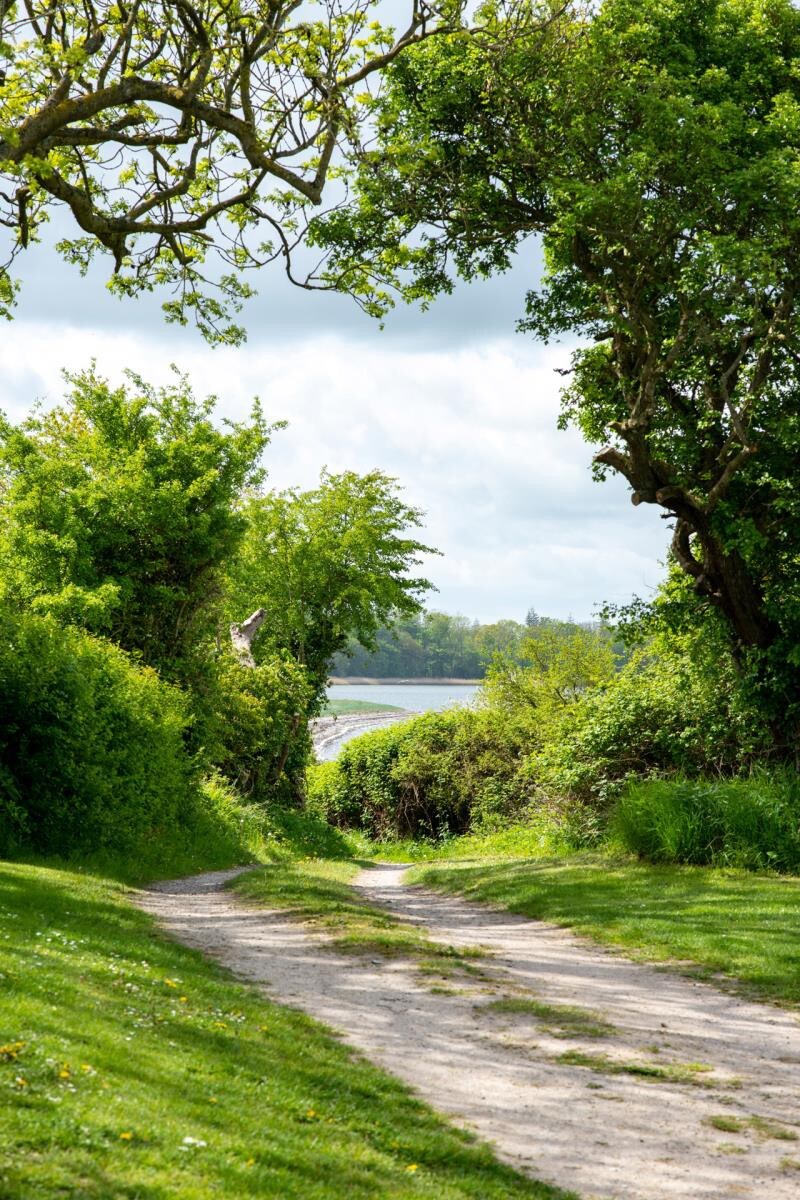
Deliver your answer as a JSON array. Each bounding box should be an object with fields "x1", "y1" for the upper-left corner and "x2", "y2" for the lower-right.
[{"x1": 410, "y1": 853, "x2": 800, "y2": 1006}]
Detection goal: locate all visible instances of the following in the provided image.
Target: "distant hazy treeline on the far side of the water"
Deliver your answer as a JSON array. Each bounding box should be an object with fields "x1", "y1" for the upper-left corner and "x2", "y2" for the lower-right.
[{"x1": 332, "y1": 608, "x2": 601, "y2": 679}]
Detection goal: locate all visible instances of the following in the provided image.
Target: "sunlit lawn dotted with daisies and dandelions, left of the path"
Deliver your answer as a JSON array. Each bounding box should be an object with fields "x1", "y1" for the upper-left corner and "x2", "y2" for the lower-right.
[{"x1": 0, "y1": 864, "x2": 575, "y2": 1200}]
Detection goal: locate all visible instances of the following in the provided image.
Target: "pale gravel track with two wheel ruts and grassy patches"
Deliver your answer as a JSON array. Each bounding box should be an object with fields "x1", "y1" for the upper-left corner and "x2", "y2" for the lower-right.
[{"x1": 142, "y1": 865, "x2": 800, "y2": 1200}]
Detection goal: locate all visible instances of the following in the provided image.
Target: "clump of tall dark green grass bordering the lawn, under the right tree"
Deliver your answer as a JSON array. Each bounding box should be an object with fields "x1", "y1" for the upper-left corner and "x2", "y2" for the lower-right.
[{"x1": 612, "y1": 768, "x2": 800, "y2": 872}]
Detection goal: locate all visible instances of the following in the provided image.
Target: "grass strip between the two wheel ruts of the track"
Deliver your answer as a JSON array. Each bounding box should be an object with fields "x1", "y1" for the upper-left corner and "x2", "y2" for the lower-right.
[{"x1": 233, "y1": 859, "x2": 485, "y2": 974}]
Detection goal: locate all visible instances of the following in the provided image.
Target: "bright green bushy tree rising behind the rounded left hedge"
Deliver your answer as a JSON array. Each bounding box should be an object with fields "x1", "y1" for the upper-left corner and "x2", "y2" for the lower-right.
[{"x1": 0, "y1": 370, "x2": 271, "y2": 682}]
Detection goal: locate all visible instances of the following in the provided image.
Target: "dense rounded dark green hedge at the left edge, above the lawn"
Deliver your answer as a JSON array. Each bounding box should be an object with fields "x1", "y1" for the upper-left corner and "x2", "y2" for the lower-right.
[{"x1": 0, "y1": 610, "x2": 194, "y2": 853}]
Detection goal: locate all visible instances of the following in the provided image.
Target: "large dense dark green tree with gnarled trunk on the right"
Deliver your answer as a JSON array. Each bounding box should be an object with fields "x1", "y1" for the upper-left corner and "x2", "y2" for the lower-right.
[{"x1": 315, "y1": 0, "x2": 800, "y2": 721}]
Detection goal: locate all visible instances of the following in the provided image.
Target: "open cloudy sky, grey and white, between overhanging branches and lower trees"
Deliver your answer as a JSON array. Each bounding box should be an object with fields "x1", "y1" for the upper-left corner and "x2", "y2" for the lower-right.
[{"x1": 0, "y1": 220, "x2": 668, "y2": 620}]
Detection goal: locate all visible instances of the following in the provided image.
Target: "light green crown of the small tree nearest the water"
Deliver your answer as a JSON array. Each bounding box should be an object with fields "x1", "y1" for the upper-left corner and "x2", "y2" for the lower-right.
[{"x1": 228, "y1": 472, "x2": 431, "y2": 715}]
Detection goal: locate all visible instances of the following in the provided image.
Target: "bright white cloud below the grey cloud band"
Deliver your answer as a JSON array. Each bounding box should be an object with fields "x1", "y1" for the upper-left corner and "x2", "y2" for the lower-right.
[{"x1": 0, "y1": 316, "x2": 667, "y2": 619}]
